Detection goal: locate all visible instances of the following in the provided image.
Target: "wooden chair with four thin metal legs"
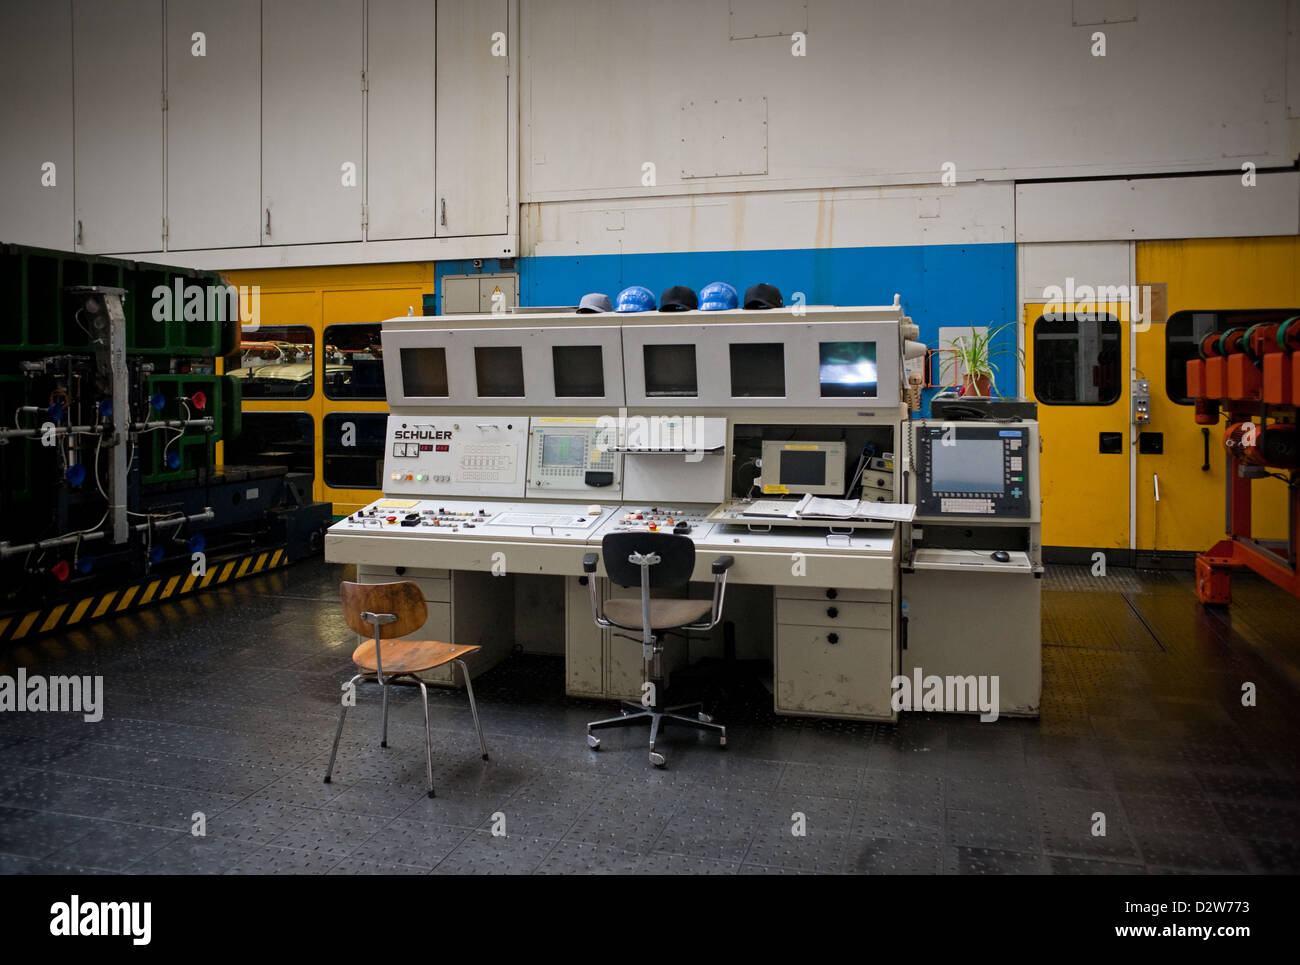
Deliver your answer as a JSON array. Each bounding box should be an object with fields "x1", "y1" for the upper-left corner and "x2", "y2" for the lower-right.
[{"x1": 325, "y1": 580, "x2": 488, "y2": 797}]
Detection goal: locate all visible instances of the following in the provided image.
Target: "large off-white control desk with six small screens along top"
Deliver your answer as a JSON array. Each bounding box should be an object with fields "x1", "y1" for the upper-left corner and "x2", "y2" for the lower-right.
[{"x1": 325, "y1": 300, "x2": 1036, "y2": 720}]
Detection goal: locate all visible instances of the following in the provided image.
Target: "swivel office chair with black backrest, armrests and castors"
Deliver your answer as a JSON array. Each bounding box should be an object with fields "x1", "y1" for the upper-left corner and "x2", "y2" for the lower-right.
[{"x1": 582, "y1": 533, "x2": 736, "y2": 767}]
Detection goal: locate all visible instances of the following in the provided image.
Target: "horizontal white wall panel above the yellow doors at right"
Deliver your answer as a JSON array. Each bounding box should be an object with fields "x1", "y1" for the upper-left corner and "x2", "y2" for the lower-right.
[{"x1": 1015, "y1": 172, "x2": 1300, "y2": 242}]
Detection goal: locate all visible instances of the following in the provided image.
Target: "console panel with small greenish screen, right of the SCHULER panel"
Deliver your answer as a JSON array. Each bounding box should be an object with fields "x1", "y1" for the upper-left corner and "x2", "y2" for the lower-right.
[{"x1": 527, "y1": 416, "x2": 623, "y2": 498}]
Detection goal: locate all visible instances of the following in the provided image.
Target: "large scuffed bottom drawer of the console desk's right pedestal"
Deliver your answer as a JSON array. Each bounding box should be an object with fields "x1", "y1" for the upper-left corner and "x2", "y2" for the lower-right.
[{"x1": 776, "y1": 624, "x2": 894, "y2": 720}]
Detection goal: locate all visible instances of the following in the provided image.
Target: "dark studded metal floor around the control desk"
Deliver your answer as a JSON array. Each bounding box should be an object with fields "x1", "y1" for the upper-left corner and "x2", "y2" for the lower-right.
[{"x1": 0, "y1": 563, "x2": 1300, "y2": 874}]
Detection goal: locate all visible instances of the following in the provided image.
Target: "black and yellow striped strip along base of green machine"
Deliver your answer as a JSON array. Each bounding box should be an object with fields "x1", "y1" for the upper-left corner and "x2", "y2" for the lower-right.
[{"x1": 0, "y1": 549, "x2": 289, "y2": 642}]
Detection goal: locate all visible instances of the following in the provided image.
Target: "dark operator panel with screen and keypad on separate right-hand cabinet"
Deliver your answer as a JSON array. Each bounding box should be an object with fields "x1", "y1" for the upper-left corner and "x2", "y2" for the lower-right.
[{"x1": 914, "y1": 423, "x2": 1037, "y2": 520}]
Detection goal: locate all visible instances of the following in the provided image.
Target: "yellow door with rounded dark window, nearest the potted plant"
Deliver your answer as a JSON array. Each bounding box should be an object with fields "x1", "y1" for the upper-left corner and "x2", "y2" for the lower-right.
[{"x1": 1024, "y1": 303, "x2": 1130, "y2": 563}]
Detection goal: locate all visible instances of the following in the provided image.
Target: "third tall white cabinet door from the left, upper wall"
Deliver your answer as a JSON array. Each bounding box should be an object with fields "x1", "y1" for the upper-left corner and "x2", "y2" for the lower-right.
[{"x1": 166, "y1": 0, "x2": 261, "y2": 251}]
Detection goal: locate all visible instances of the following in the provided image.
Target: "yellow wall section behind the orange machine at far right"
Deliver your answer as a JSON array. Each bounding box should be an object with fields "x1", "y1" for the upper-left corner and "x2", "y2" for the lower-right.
[{"x1": 1133, "y1": 237, "x2": 1300, "y2": 551}]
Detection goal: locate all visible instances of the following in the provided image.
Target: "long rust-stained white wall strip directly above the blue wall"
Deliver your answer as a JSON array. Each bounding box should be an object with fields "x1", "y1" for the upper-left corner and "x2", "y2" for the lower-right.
[{"x1": 520, "y1": 182, "x2": 1015, "y2": 255}]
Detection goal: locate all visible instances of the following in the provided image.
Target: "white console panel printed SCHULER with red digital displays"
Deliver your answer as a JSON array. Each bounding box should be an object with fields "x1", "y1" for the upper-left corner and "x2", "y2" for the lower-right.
[{"x1": 384, "y1": 415, "x2": 528, "y2": 499}]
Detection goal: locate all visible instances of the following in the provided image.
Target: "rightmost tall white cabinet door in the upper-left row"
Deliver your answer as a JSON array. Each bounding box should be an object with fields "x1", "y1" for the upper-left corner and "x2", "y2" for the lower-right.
[{"x1": 437, "y1": 0, "x2": 512, "y2": 237}]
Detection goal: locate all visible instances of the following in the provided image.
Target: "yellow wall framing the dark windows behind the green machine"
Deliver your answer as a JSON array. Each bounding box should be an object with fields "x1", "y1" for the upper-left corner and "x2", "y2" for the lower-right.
[{"x1": 215, "y1": 261, "x2": 434, "y2": 514}]
